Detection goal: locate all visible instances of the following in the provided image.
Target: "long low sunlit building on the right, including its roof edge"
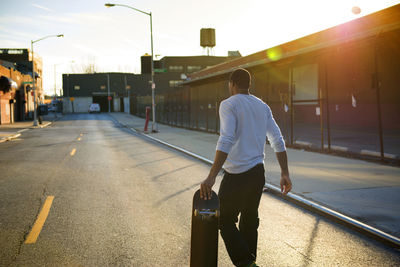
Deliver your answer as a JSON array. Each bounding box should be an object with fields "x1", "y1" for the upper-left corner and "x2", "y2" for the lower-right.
[{"x1": 138, "y1": 9, "x2": 400, "y2": 158}]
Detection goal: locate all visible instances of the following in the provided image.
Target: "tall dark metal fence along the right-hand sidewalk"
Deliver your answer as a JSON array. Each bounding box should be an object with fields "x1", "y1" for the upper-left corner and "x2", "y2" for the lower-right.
[{"x1": 137, "y1": 37, "x2": 400, "y2": 160}]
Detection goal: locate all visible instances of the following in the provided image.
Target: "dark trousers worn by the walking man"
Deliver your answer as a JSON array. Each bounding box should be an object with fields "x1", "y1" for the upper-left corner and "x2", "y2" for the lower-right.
[{"x1": 218, "y1": 164, "x2": 265, "y2": 266}]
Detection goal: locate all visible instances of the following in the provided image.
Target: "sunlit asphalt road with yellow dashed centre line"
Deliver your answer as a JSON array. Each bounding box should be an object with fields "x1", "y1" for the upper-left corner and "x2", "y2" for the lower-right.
[{"x1": 0, "y1": 114, "x2": 400, "y2": 266}]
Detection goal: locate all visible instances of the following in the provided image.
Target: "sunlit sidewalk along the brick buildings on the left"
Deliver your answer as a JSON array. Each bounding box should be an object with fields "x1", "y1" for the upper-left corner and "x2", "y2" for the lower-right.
[{"x1": 0, "y1": 113, "x2": 62, "y2": 143}]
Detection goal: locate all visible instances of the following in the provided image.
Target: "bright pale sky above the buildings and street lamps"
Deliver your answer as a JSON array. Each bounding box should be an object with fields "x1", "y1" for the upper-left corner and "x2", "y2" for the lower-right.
[{"x1": 0, "y1": 0, "x2": 400, "y2": 95}]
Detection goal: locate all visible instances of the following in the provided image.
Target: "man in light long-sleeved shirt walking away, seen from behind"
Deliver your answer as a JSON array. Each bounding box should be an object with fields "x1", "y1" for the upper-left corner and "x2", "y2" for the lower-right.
[{"x1": 200, "y1": 69, "x2": 292, "y2": 266}]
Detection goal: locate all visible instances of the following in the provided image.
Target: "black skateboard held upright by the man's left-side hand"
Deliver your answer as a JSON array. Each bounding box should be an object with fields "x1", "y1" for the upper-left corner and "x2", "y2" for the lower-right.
[{"x1": 190, "y1": 190, "x2": 219, "y2": 267}]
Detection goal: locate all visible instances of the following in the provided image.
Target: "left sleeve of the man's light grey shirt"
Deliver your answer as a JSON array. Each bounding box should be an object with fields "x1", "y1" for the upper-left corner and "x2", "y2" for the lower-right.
[{"x1": 216, "y1": 101, "x2": 236, "y2": 154}]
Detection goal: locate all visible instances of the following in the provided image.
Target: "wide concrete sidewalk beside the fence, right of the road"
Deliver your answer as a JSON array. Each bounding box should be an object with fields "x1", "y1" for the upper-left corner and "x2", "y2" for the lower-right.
[{"x1": 111, "y1": 113, "x2": 400, "y2": 242}]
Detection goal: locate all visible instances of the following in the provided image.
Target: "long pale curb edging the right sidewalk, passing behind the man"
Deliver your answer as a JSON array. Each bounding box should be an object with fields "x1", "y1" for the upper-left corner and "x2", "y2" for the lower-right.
[{"x1": 120, "y1": 123, "x2": 400, "y2": 249}]
